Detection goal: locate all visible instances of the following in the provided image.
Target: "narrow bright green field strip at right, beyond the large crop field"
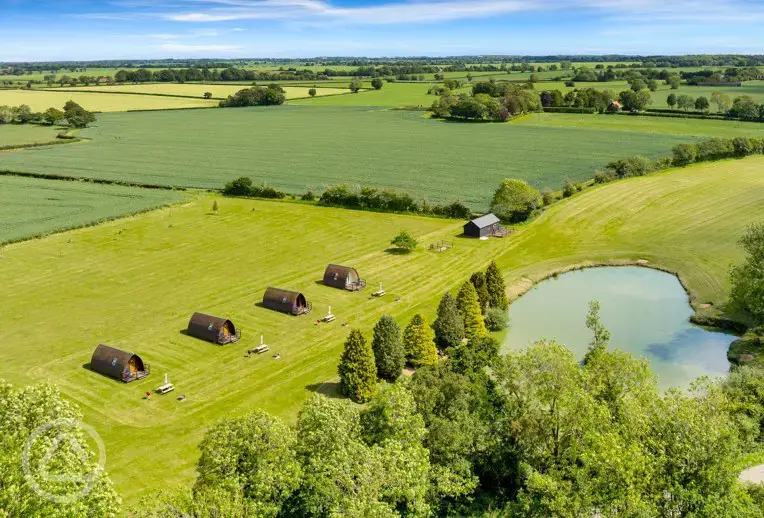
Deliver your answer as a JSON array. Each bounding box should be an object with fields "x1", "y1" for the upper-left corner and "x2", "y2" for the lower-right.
[{"x1": 511, "y1": 113, "x2": 764, "y2": 138}]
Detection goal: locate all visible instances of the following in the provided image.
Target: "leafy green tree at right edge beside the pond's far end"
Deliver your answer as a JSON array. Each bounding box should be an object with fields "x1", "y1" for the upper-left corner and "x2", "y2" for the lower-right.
[{"x1": 730, "y1": 223, "x2": 764, "y2": 322}]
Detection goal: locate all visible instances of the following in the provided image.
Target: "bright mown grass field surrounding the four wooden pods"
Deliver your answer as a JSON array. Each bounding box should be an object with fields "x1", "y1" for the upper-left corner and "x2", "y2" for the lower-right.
[{"x1": 0, "y1": 158, "x2": 764, "y2": 502}]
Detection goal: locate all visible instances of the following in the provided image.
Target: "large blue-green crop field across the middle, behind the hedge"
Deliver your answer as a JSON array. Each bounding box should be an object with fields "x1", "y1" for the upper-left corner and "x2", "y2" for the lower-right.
[{"x1": 0, "y1": 106, "x2": 688, "y2": 210}]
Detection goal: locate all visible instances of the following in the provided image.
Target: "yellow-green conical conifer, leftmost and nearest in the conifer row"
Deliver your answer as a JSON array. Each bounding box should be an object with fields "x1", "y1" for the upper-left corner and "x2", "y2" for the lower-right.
[{"x1": 337, "y1": 329, "x2": 377, "y2": 403}]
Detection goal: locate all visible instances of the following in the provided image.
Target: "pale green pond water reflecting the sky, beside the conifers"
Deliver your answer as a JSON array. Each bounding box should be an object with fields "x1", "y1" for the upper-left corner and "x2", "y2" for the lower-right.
[{"x1": 504, "y1": 266, "x2": 736, "y2": 388}]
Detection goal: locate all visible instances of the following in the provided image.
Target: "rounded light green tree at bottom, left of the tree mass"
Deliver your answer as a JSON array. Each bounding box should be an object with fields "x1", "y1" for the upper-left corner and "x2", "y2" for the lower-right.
[{"x1": 194, "y1": 410, "x2": 301, "y2": 516}]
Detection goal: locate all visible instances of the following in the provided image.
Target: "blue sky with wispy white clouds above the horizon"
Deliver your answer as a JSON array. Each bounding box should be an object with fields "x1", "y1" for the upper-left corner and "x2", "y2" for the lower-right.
[{"x1": 0, "y1": 0, "x2": 764, "y2": 62}]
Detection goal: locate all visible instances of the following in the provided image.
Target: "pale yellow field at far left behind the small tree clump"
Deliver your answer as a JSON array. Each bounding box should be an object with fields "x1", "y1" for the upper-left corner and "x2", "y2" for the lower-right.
[{"x1": 0, "y1": 90, "x2": 220, "y2": 112}]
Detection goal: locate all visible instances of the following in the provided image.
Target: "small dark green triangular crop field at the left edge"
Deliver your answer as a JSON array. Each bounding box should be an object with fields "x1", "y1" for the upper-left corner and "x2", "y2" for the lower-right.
[{"x1": 0, "y1": 176, "x2": 184, "y2": 244}]
